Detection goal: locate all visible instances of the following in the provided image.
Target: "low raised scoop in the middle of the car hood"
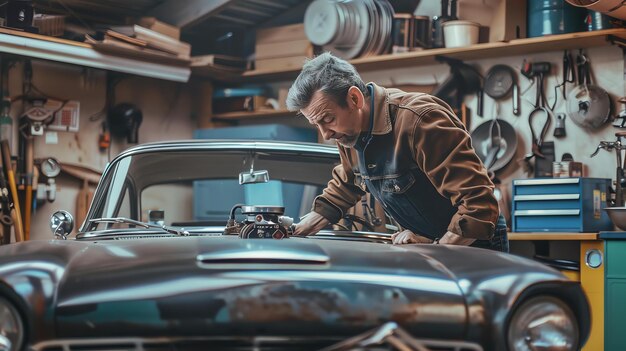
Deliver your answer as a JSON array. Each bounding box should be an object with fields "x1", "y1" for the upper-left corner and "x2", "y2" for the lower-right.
[{"x1": 196, "y1": 242, "x2": 330, "y2": 268}]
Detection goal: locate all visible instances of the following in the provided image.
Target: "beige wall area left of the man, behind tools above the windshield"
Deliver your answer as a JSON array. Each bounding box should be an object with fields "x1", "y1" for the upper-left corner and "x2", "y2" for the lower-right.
[{"x1": 4, "y1": 61, "x2": 196, "y2": 239}]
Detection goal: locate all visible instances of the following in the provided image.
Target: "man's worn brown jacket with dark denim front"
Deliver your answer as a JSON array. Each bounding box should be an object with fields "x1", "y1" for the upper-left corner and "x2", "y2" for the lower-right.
[{"x1": 313, "y1": 83, "x2": 499, "y2": 239}]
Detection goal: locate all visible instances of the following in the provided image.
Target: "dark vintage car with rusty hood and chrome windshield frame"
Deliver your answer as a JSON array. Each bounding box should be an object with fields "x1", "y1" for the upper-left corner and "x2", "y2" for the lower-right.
[{"x1": 0, "y1": 140, "x2": 591, "y2": 351}]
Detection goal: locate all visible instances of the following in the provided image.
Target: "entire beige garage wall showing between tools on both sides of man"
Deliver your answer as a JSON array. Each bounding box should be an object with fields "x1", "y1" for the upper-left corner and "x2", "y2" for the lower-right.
[{"x1": 10, "y1": 42, "x2": 624, "y2": 239}]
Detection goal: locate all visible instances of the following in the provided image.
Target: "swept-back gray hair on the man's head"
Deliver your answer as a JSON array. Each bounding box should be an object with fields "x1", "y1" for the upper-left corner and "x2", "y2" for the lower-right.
[{"x1": 287, "y1": 52, "x2": 369, "y2": 111}]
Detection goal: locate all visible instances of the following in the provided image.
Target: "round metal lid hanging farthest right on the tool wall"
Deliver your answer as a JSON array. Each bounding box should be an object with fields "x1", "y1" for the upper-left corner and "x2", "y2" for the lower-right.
[{"x1": 567, "y1": 84, "x2": 611, "y2": 129}]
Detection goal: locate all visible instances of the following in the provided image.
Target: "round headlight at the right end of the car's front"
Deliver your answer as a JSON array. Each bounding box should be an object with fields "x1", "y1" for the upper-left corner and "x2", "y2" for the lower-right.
[{"x1": 508, "y1": 296, "x2": 579, "y2": 351}]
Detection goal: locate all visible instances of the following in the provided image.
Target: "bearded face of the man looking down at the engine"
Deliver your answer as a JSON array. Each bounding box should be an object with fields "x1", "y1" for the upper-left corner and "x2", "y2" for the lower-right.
[{"x1": 301, "y1": 91, "x2": 361, "y2": 147}]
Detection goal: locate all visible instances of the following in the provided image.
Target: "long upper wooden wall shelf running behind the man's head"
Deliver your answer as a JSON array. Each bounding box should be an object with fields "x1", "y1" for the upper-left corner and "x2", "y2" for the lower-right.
[{"x1": 192, "y1": 28, "x2": 626, "y2": 82}]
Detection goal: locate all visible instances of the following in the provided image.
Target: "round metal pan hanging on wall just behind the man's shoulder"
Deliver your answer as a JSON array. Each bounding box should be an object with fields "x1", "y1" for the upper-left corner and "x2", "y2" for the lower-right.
[{"x1": 472, "y1": 119, "x2": 517, "y2": 172}]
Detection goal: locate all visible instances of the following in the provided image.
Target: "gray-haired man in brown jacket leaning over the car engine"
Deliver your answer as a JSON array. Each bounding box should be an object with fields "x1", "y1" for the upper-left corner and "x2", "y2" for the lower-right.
[{"x1": 287, "y1": 53, "x2": 508, "y2": 251}]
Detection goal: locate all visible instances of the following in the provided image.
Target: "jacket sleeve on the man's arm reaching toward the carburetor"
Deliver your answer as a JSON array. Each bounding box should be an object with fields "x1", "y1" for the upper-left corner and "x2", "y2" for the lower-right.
[{"x1": 313, "y1": 147, "x2": 365, "y2": 223}]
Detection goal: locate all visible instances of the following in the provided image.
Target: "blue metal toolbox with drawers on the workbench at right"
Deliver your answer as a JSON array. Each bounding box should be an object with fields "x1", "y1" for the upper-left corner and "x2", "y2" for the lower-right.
[{"x1": 512, "y1": 178, "x2": 613, "y2": 233}]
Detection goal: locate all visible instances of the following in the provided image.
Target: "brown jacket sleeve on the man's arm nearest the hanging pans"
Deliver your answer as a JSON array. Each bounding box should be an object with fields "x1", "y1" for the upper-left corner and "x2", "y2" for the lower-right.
[{"x1": 411, "y1": 107, "x2": 499, "y2": 239}]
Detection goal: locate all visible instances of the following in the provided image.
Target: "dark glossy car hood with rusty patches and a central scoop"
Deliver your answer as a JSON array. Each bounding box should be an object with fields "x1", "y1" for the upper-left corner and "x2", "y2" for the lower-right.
[{"x1": 40, "y1": 237, "x2": 467, "y2": 338}]
